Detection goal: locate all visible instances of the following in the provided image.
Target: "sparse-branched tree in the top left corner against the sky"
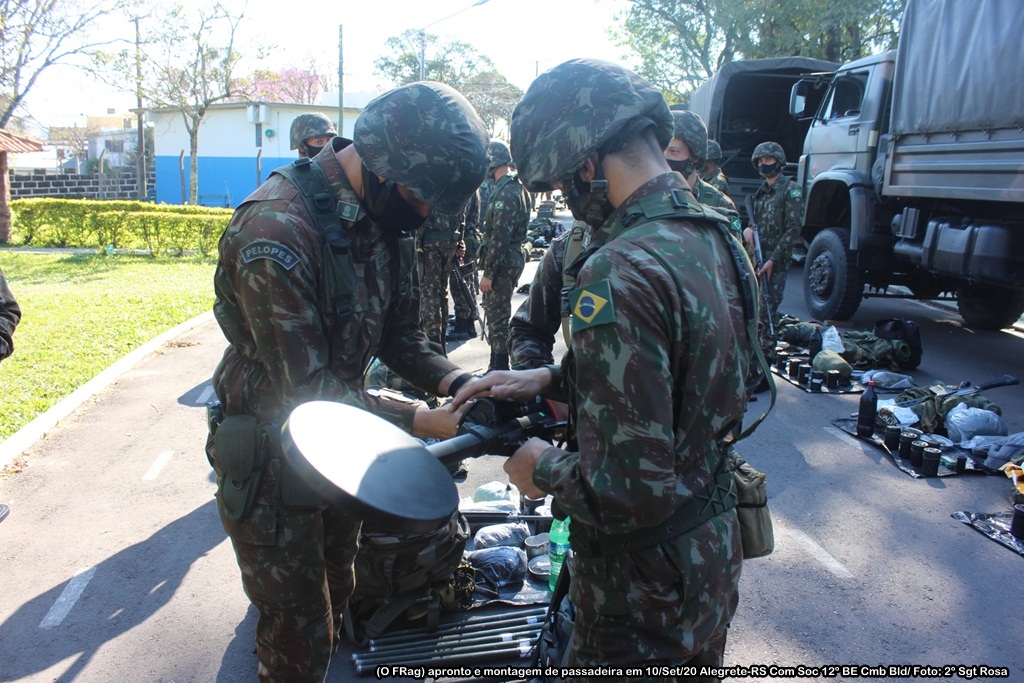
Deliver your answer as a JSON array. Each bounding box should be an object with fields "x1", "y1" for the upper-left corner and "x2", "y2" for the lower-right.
[{"x1": 0, "y1": 0, "x2": 122, "y2": 128}]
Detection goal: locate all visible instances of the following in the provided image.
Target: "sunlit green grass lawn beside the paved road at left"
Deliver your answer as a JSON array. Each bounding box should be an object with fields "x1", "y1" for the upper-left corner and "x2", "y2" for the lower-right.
[{"x1": 0, "y1": 251, "x2": 216, "y2": 441}]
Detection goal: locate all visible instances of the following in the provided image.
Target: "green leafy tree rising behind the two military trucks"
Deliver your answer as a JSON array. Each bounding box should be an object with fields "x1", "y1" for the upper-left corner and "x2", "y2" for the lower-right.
[{"x1": 614, "y1": 0, "x2": 906, "y2": 101}]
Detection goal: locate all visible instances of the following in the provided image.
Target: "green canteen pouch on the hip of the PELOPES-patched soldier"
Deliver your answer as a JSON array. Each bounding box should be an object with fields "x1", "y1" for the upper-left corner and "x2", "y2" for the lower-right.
[{"x1": 214, "y1": 415, "x2": 265, "y2": 522}]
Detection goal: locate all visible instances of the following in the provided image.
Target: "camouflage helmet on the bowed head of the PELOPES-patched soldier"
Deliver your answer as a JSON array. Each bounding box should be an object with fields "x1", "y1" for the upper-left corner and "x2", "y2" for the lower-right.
[{"x1": 352, "y1": 81, "x2": 487, "y2": 214}]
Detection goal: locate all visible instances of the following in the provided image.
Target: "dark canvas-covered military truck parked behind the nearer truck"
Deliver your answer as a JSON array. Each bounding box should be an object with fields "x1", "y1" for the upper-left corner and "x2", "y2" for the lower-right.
[{"x1": 689, "y1": 57, "x2": 839, "y2": 200}]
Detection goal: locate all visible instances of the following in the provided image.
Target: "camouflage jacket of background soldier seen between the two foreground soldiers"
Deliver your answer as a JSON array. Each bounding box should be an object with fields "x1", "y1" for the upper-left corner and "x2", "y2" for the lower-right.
[{"x1": 481, "y1": 171, "x2": 529, "y2": 279}]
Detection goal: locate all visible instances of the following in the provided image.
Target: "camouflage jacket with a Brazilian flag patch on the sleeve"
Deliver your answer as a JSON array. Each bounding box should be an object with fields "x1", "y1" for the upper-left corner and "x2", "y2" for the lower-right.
[{"x1": 534, "y1": 173, "x2": 756, "y2": 626}]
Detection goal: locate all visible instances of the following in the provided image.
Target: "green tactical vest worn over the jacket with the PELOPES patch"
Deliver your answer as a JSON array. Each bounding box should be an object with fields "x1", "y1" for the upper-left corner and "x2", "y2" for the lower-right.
[{"x1": 270, "y1": 159, "x2": 415, "y2": 342}]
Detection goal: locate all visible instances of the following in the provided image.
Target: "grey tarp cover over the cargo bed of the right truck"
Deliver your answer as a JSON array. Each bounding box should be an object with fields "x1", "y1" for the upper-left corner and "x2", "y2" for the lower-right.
[{"x1": 892, "y1": 0, "x2": 1024, "y2": 135}]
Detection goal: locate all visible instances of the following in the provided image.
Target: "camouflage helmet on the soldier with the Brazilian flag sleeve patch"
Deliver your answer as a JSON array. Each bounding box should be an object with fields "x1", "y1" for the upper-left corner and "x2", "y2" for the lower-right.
[{"x1": 511, "y1": 59, "x2": 672, "y2": 191}]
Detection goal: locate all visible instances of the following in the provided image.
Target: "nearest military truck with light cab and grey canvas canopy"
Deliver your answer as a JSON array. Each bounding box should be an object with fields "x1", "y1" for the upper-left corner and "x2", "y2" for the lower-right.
[{"x1": 790, "y1": 0, "x2": 1024, "y2": 330}]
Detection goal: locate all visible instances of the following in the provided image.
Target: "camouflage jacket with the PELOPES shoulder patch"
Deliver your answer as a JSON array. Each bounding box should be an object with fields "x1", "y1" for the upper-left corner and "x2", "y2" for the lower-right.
[{"x1": 214, "y1": 143, "x2": 456, "y2": 428}]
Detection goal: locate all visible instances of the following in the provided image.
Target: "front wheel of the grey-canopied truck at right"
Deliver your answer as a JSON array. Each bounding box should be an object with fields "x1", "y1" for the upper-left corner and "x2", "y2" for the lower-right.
[{"x1": 804, "y1": 227, "x2": 864, "y2": 321}]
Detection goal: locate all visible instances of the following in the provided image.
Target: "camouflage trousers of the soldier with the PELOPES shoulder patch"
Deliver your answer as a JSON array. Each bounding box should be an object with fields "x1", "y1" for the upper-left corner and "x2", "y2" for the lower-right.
[{"x1": 218, "y1": 459, "x2": 359, "y2": 683}]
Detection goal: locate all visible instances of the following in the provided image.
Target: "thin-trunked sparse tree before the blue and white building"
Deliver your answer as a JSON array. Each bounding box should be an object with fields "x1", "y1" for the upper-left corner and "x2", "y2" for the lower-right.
[{"x1": 98, "y1": 0, "x2": 245, "y2": 204}]
